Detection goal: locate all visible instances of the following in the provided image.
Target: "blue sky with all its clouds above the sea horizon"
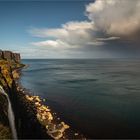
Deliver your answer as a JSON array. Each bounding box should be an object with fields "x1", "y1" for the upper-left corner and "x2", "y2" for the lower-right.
[{"x1": 0, "y1": 0, "x2": 140, "y2": 59}]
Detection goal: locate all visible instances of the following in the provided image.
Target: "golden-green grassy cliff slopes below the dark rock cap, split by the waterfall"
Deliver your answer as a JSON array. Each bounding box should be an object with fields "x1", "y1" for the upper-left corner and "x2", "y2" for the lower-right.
[{"x1": 0, "y1": 60, "x2": 17, "y2": 139}]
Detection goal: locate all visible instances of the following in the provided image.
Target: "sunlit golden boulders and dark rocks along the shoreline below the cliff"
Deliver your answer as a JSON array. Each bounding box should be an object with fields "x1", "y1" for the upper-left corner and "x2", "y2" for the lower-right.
[{"x1": 14, "y1": 83, "x2": 85, "y2": 139}]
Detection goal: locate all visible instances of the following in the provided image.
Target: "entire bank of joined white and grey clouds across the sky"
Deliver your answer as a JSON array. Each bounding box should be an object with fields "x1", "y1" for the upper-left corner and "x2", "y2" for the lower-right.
[{"x1": 29, "y1": 0, "x2": 140, "y2": 57}]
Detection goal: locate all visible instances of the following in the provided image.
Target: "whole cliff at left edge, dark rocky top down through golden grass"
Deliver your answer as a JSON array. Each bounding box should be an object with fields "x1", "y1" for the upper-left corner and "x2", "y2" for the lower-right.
[{"x1": 0, "y1": 50, "x2": 23, "y2": 139}]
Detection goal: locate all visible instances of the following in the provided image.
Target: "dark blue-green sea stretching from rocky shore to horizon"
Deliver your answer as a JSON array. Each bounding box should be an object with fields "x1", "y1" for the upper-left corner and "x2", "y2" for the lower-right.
[{"x1": 21, "y1": 59, "x2": 140, "y2": 138}]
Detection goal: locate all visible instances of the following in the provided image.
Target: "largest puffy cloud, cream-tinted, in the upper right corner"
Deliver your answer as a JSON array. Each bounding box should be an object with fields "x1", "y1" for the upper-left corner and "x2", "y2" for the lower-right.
[{"x1": 86, "y1": 0, "x2": 140, "y2": 36}]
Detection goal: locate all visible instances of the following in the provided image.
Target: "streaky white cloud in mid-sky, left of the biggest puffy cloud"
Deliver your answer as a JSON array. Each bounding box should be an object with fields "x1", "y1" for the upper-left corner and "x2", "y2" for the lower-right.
[{"x1": 30, "y1": 21, "x2": 102, "y2": 47}]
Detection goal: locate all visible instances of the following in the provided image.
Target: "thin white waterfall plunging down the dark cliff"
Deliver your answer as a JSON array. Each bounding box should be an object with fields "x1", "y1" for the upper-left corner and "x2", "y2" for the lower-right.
[{"x1": 0, "y1": 86, "x2": 17, "y2": 139}]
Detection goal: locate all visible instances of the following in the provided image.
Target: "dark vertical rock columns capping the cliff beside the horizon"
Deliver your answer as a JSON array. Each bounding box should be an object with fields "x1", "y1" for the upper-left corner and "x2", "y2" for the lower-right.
[{"x1": 0, "y1": 50, "x2": 20, "y2": 62}]
